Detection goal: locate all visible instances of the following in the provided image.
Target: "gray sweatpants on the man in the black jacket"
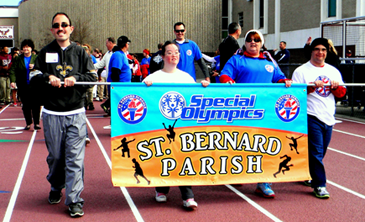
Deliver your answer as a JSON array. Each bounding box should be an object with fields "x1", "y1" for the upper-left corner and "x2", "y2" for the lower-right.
[{"x1": 43, "y1": 113, "x2": 86, "y2": 205}]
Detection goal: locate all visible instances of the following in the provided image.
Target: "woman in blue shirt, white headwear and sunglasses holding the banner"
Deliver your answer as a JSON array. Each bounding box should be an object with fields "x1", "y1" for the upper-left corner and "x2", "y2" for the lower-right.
[{"x1": 219, "y1": 30, "x2": 292, "y2": 198}]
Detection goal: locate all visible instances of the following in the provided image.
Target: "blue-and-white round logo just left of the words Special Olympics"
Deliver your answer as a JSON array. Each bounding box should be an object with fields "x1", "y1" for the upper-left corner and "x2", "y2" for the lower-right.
[{"x1": 160, "y1": 91, "x2": 186, "y2": 119}]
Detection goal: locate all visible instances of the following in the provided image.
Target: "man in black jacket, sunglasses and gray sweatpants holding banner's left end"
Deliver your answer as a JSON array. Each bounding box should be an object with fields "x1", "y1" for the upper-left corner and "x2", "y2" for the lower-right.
[{"x1": 32, "y1": 12, "x2": 97, "y2": 217}]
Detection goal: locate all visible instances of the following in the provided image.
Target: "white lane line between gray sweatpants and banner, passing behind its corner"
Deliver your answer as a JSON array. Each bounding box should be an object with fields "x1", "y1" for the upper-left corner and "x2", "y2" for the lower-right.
[{"x1": 86, "y1": 118, "x2": 144, "y2": 222}]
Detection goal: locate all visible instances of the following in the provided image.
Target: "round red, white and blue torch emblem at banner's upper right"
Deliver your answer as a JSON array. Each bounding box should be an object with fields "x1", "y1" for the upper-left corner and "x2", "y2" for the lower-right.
[{"x1": 275, "y1": 95, "x2": 300, "y2": 122}]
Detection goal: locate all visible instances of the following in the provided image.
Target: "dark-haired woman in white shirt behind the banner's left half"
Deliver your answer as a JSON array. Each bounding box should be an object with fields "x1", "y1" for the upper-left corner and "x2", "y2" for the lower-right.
[{"x1": 143, "y1": 41, "x2": 209, "y2": 209}]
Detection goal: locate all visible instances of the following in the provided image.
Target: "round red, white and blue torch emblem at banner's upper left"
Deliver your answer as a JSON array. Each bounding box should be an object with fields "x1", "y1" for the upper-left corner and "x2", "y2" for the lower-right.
[{"x1": 118, "y1": 95, "x2": 147, "y2": 124}]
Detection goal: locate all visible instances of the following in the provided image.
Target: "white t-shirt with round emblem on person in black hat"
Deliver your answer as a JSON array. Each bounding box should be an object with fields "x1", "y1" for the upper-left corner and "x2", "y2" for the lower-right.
[{"x1": 292, "y1": 61, "x2": 343, "y2": 126}]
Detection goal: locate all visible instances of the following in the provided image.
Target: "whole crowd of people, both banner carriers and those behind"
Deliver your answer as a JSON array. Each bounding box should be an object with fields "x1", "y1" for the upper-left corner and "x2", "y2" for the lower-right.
[{"x1": 0, "y1": 13, "x2": 346, "y2": 217}]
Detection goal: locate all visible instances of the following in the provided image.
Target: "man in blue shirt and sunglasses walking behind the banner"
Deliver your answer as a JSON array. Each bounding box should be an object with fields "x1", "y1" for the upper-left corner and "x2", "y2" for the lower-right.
[{"x1": 173, "y1": 22, "x2": 210, "y2": 82}]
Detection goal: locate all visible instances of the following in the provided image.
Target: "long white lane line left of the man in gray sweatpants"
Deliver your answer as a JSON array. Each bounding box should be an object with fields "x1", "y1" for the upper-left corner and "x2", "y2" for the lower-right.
[{"x1": 3, "y1": 130, "x2": 37, "y2": 222}]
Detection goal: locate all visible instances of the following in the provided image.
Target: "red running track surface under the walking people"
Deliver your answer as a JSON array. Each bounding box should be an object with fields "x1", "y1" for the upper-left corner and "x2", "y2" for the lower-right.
[{"x1": 0, "y1": 102, "x2": 365, "y2": 222}]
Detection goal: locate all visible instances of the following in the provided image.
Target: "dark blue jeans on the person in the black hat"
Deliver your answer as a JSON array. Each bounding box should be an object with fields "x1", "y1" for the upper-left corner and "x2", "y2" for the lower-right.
[{"x1": 308, "y1": 115, "x2": 332, "y2": 188}]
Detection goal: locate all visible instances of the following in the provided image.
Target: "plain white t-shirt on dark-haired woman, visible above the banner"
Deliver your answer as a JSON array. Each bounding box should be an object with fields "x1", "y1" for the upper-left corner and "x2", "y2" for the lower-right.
[{"x1": 143, "y1": 69, "x2": 195, "y2": 83}]
